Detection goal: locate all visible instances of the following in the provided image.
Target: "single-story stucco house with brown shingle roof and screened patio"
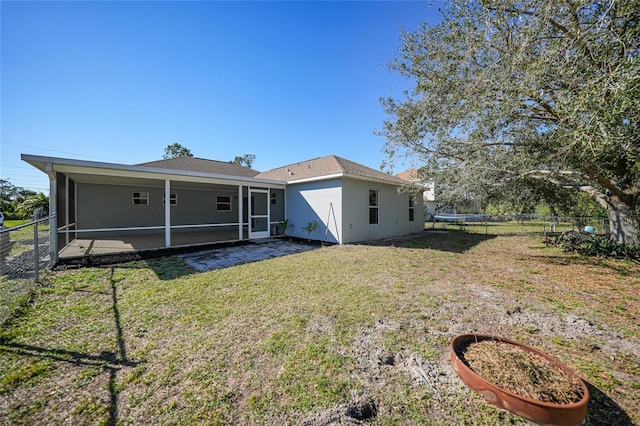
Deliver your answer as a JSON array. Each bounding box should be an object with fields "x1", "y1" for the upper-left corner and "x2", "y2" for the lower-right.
[{"x1": 22, "y1": 154, "x2": 424, "y2": 260}]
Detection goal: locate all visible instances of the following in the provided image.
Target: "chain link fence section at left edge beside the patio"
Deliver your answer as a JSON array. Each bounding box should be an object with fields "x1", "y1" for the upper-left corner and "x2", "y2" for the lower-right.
[{"x1": 0, "y1": 216, "x2": 55, "y2": 324}]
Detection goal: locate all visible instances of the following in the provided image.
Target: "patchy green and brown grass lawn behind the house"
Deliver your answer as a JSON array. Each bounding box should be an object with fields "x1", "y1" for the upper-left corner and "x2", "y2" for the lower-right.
[{"x1": 0, "y1": 231, "x2": 640, "y2": 425}]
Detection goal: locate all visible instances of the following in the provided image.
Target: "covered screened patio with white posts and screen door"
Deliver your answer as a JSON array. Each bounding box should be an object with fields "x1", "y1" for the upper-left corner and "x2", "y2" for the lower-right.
[{"x1": 22, "y1": 154, "x2": 286, "y2": 260}]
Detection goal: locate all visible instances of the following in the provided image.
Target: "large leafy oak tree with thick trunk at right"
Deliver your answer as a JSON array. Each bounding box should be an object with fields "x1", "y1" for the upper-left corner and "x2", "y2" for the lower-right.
[{"x1": 382, "y1": 0, "x2": 640, "y2": 244}]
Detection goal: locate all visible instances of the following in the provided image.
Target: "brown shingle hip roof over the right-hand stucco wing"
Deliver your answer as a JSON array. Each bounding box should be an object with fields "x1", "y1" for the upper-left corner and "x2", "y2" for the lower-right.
[{"x1": 255, "y1": 155, "x2": 407, "y2": 185}]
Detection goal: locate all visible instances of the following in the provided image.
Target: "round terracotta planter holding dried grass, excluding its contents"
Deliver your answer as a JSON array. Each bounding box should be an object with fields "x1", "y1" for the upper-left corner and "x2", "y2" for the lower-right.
[{"x1": 451, "y1": 334, "x2": 589, "y2": 426}]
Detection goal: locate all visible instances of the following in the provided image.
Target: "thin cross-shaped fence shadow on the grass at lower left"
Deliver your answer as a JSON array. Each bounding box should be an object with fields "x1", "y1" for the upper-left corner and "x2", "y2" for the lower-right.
[{"x1": 0, "y1": 267, "x2": 138, "y2": 425}]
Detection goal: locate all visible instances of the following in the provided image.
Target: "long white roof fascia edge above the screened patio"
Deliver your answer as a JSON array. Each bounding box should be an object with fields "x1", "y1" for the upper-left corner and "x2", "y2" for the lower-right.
[{"x1": 21, "y1": 154, "x2": 285, "y2": 188}]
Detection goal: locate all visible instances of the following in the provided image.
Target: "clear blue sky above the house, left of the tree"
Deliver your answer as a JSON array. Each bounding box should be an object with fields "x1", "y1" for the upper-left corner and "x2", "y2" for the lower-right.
[{"x1": 0, "y1": 1, "x2": 439, "y2": 192}]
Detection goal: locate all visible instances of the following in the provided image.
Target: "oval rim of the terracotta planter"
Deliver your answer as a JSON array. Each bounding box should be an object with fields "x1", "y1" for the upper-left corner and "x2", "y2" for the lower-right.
[{"x1": 449, "y1": 334, "x2": 589, "y2": 415}]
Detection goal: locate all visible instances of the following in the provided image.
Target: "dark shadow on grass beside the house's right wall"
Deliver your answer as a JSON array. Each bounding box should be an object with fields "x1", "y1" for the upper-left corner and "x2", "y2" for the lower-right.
[{"x1": 364, "y1": 230, "x2": 496, "y2": 253}]
